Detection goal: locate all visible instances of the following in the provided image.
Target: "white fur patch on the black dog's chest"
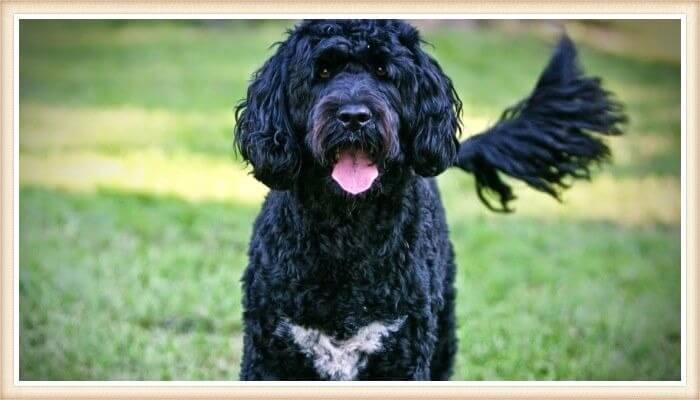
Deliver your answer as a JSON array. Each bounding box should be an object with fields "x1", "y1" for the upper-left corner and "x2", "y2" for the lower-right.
[{"x1": 276, "y1": 317, "x2": 406, "y2": 380}]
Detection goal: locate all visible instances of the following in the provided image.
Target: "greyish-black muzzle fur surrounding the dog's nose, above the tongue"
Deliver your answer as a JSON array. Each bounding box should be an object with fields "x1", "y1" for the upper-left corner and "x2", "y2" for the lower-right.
[{"x1": 307, "y1": 74, "x2": 399, "y2": 164}]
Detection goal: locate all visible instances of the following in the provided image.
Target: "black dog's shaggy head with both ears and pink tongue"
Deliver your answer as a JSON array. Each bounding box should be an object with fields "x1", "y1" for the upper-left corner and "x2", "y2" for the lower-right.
[{"x1": 235, "y1": 20, "x2": 461, "y2": 197}]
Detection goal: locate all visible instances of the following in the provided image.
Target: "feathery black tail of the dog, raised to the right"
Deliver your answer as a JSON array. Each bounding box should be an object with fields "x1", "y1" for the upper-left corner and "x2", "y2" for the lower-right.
[{"x1": 457, "y1": 36, "x2": 627, "y2": 212}]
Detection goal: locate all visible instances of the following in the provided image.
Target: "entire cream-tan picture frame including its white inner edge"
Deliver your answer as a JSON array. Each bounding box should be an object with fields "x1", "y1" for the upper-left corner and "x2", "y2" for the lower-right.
[{"x1": 0, "y1": 0, "x2": 700, "y2": 399}]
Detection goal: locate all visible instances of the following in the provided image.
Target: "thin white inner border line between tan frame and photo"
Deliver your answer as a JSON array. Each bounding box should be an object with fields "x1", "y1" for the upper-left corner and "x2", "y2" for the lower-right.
[{"x1": 12, "y1": 13, "x2": 688, "y2": 388}]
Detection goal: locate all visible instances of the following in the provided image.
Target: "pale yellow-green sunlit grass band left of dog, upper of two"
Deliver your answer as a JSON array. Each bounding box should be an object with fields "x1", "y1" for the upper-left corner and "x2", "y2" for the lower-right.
[{"x1": 19, "y1": 103, "x2": 234, "y2": 158}]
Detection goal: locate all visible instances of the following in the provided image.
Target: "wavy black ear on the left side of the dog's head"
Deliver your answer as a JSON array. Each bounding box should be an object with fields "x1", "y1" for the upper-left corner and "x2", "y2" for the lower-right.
[{"x1": 234, "y1": 43, "x2": 301, "y2": 190}]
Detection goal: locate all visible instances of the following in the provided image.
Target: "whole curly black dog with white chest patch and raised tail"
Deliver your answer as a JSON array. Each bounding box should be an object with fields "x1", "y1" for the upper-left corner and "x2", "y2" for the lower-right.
[{"x1": 235, "y1": 20, "x2": 624, "y2": 380}]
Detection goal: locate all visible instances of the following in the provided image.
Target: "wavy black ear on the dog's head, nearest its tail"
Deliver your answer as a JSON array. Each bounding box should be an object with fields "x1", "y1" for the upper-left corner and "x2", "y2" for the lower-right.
[{"x1": 409, "y1": 44, "x2": 462, "y2": 176}]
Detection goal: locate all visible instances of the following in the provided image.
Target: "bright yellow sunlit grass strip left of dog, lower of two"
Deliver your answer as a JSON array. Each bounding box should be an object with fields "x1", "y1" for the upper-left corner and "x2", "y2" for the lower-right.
[{"x1": 20, "y1": 148, "x2": 267, "y2": 204}]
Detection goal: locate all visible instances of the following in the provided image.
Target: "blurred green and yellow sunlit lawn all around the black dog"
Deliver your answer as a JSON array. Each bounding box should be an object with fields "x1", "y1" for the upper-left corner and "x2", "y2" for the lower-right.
[{"x1": 19, "y1": 20, "x2": 681, "y2": 380}]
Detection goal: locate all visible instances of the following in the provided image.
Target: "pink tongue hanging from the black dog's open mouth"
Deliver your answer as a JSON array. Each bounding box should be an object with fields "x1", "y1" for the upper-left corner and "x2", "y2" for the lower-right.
[{"x1": 331, "y1": 151, "x2": 379, "y2": 194}]
